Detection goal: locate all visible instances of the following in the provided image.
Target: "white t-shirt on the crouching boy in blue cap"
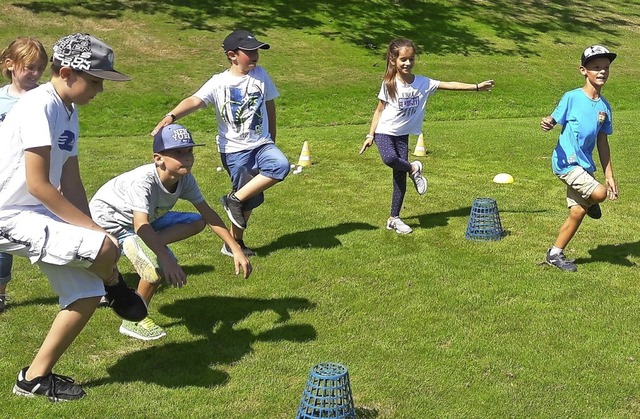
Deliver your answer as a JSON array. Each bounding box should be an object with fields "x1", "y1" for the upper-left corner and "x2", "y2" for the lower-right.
[{"x1": 89, "y1": 163, "x2": 204, "y2": 237}]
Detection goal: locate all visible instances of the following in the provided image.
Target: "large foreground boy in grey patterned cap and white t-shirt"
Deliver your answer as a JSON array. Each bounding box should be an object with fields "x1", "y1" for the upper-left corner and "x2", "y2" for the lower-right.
[{"x1": 0, "y1": 33, "x2": 147, "y2": 401}]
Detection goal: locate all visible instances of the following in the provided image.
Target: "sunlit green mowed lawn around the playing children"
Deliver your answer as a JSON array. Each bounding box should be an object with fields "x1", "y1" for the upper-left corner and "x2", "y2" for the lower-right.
[{"x1": 0, "y1": 1, "x2": 640, "y2": 418}]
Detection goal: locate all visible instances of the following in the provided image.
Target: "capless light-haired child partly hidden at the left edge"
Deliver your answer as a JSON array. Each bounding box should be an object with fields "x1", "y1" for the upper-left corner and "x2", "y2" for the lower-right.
[{"x1": 0, "y1": 37, "x2": 49, "y2": 312}]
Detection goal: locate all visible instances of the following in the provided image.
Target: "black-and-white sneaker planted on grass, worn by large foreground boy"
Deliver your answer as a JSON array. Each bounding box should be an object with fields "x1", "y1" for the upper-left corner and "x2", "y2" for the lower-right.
[{"x1": 13, "y1": 367, "x2": 87, "y2": 402}]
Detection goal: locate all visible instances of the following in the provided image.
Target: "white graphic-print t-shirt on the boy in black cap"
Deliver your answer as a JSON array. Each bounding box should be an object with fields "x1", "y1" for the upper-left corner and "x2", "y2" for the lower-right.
[{"x1": 194, "y1": 67, "x2": 280, "y2": 153}]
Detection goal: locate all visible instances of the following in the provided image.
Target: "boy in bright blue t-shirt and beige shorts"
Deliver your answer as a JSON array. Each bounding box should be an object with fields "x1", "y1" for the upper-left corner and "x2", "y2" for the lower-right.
[{"x1": 540, "y1": 45, "x2": 618, "y2": 272}]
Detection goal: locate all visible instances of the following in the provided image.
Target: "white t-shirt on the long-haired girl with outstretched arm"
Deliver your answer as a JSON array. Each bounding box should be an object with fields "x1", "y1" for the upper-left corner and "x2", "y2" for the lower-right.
[{"x1": 375, "y1": 75, "x2": 440, "y2": 135}]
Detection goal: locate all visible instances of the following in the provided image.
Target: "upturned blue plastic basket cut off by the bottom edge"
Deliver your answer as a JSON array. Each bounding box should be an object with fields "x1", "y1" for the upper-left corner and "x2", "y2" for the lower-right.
[{"x1": 296, "y1": 362, "x2": 356, "y2": 419}]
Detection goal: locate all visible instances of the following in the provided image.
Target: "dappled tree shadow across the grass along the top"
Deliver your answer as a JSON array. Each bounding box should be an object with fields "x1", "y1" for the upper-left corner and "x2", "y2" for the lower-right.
[{"x1": 13, "y1": 0, "x2": 640, "y2": 56}]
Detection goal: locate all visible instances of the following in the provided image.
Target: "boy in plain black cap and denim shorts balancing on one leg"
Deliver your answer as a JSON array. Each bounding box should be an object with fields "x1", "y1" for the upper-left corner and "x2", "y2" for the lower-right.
[{"x1": 151, "y1": 30, "x2": 290, "y2": 256}]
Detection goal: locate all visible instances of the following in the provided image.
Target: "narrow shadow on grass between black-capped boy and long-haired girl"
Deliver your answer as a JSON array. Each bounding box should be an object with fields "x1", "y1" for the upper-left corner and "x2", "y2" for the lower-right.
[{"x1": 254, "y1": 222, "x2": 378, "y2": 256}]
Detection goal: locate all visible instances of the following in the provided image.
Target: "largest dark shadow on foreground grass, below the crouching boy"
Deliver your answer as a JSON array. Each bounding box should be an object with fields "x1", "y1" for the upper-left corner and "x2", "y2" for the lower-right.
[{"x1": 87, "y1": 296, "x2": 316, "y2": 388}]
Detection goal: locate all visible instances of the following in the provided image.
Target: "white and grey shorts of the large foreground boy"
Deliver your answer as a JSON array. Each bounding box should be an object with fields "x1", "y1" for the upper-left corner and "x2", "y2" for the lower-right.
[{"x1": 0, "y1": 207, "x2": 106, "y2": 308}]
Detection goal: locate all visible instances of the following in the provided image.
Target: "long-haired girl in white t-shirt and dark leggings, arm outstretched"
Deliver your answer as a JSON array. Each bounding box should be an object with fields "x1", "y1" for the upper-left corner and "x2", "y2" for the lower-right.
[{"x1": 360, "y1": 38, "x2": 494, "y2": 234}]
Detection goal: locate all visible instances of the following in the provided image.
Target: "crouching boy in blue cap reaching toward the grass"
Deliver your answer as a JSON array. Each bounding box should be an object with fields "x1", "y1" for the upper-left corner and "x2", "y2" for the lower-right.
[{"x1": 89, "y1": 124, "x2": 251, "y2": 340}]
